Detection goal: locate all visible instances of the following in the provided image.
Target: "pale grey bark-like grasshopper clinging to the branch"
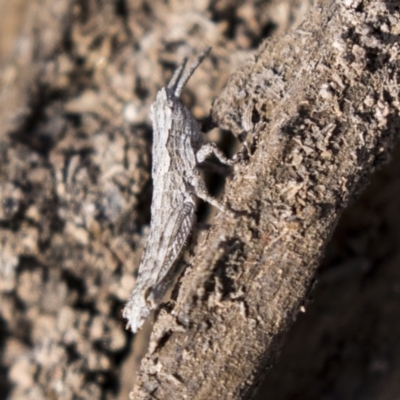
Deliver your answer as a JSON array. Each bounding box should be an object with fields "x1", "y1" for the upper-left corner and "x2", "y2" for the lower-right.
[{"x1": 123, "y1": 48, "x2": 233, "y2": 332}]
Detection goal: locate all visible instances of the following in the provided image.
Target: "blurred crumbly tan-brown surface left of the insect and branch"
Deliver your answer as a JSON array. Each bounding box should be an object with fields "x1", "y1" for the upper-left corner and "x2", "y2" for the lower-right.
[{"x1": 0, "y1": 0, "x2": 306, "y2": 400}]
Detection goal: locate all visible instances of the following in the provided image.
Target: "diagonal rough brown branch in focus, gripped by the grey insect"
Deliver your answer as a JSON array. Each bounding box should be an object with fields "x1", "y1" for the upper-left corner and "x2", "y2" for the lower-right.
[{"x1": 132, "y1": 0, "x2": 400, "y2": 400}]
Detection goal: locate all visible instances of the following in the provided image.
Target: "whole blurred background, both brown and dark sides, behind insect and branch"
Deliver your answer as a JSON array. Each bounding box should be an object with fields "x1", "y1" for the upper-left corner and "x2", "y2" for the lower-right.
[{"x1": 0, "y1": 0, "x2": 400, "y2": 400}]
